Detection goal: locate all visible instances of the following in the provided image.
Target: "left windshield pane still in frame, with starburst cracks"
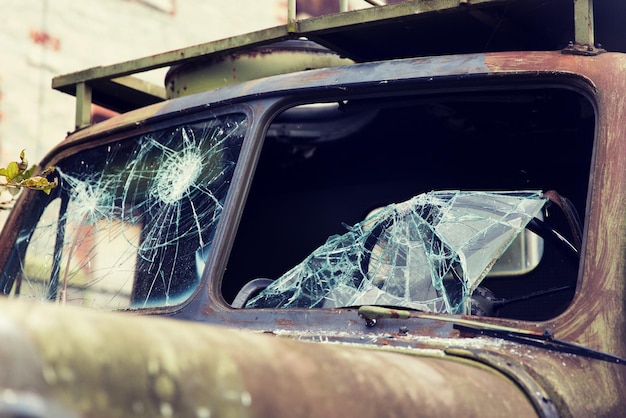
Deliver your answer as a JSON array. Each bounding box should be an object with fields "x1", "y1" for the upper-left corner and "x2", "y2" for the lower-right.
[{"x1": 2, "y1": 114, "x2": 247, "y2": 309}]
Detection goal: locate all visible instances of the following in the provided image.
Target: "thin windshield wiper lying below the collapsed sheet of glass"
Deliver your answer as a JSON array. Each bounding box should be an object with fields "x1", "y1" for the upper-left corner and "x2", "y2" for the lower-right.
[{"x1": 359, "y1": 306, "x2": 626, "y2": 364}]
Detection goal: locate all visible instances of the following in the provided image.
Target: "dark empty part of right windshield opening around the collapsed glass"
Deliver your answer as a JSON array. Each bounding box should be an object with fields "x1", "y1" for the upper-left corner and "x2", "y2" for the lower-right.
[{"x1": 222, "y1": 88, "x2": 594, "y2": 320}]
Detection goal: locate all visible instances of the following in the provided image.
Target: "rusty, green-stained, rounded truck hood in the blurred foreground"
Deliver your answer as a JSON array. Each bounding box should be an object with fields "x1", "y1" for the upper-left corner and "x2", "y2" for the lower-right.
[{"x1": 0, "y1": 300, "x2": 541, "y2": 417}]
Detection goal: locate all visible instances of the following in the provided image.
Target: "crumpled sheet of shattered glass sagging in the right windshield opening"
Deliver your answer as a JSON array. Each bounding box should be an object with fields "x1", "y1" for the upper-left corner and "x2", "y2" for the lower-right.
[{"x1": 246, "y1": 191, "x2": 546, "y2": 314}]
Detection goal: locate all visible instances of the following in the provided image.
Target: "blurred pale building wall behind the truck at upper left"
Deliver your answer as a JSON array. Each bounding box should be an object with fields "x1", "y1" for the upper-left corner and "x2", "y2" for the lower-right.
[{"x1": 0, "y1": 0, "x2": 376, "y2": 165}]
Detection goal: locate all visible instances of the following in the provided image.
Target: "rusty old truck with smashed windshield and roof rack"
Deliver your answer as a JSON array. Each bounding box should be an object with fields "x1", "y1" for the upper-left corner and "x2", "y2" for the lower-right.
[{"x1": 0, "y1": 0, "x2": 626, "y2": 418}]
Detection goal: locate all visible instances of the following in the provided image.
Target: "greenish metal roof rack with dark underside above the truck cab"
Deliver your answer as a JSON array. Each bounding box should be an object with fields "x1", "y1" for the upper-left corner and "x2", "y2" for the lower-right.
[{"x1": 52, "y1": 0, "x2": 595, "y2": 129}]
